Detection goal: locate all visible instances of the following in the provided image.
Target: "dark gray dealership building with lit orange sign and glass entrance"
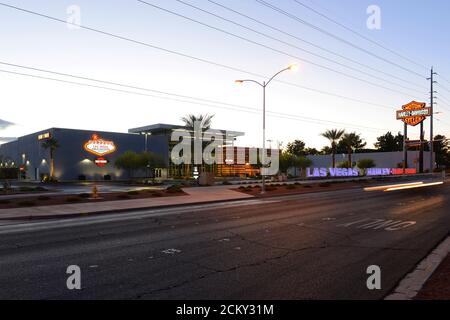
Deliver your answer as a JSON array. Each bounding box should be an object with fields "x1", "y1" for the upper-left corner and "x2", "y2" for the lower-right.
[{"x1": 0, "y1": 124, "x2": 259, "y2": 181}]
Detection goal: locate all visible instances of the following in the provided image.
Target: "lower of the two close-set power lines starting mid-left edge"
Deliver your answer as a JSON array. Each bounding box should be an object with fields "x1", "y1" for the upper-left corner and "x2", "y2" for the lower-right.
[{"x1": 0, "y1": 69, "x2": 386, "y2": 131}]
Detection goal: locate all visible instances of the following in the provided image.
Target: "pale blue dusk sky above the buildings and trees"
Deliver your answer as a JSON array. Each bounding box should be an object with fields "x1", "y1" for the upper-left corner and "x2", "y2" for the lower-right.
[{"x1": 0, "y1": 0, "x2": 450, "y2": 148}]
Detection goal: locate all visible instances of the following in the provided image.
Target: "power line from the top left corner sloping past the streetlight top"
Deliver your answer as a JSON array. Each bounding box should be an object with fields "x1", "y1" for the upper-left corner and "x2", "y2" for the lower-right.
[{"x1": 0, "y1": 2, "x2": 398, "y2": 109}]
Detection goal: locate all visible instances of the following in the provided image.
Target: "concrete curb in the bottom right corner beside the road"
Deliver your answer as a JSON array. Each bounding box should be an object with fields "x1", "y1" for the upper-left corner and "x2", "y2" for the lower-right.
[{"x1": 385, "y1": 236, "x2": 450, "y2": 300}]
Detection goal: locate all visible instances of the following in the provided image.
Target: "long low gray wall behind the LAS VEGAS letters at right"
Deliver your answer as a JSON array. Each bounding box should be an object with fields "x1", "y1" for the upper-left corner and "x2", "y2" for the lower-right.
[{"x1": 308, "y1": 151, "x2": 434, "y2": 170}]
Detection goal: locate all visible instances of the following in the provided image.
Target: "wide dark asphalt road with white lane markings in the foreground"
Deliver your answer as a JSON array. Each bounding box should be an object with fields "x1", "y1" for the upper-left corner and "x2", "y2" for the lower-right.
[{"x1": 0, "y1": 184, "x2": 450, "y2": 299}]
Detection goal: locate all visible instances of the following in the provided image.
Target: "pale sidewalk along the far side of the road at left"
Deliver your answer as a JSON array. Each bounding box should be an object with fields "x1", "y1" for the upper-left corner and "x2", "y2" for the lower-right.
[{"x1": 0, "y1": 187, "x2": 253, "y2": 220}]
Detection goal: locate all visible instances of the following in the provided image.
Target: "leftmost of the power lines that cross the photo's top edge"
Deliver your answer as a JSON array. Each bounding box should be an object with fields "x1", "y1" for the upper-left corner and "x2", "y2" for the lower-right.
[{"x1": 136, "y1": 0, "x2": 422, "y2": 97}]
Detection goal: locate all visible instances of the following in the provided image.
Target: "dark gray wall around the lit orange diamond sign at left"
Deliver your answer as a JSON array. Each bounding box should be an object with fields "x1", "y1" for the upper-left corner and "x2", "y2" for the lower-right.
[{"x1": 0, "y1": 128, "x2": 169, "y2": 181}]
